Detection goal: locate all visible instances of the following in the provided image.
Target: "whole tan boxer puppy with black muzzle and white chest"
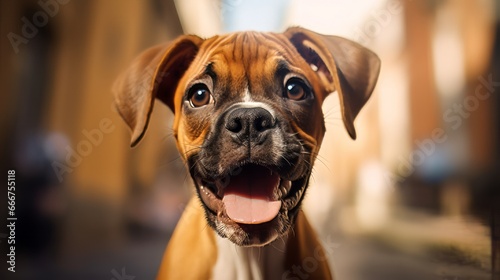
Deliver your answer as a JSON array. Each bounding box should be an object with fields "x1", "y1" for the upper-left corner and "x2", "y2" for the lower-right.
[{"x1": 114, "y1": 27, "x2": 380, "y2": 279}]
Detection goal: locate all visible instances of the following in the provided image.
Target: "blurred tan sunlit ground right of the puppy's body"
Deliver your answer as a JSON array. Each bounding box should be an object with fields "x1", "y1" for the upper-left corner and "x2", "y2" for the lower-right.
[{"x1": 333, "y1": 214, "x2": 491, "y2": 280}]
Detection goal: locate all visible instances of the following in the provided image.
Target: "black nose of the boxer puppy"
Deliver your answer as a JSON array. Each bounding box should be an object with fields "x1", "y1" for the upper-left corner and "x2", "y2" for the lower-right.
[{"x1": 226, "y1": 107, "x2": 276, "y2": 142}]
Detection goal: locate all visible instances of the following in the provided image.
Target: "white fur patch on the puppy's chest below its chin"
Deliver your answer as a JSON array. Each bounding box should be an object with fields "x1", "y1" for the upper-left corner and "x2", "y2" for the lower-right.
[{"x1": 212, "y1": 236, "x2": 287, "y2": 280}]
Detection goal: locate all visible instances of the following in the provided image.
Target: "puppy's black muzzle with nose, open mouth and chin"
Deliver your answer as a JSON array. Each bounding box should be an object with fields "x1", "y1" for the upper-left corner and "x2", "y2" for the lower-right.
[{"x1": 188, "y1": 107, "x2": 310, "y2": 245}]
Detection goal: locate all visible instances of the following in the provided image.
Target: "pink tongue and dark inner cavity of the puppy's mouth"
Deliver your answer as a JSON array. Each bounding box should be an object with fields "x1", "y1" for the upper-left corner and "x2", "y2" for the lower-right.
[{"x1": 222, "y1": 165, "x2": 281, "y2": 224}]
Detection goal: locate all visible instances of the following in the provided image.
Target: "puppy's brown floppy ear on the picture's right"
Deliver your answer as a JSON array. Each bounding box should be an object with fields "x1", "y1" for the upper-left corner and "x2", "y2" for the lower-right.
[{"x1": 284, "y1": 27, "x2": 380, "y2": 139}]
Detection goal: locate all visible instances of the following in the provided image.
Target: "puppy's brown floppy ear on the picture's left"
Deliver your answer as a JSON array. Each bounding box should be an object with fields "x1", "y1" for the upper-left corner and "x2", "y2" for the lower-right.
[{"x1": 113, "y1": 35, "x2": 203, "y2": 147}]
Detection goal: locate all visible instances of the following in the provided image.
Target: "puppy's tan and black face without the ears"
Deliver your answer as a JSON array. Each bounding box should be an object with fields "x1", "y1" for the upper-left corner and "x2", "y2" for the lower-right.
[{"x1": 180, "y1": 33, "x2": 325, "y2": 245}]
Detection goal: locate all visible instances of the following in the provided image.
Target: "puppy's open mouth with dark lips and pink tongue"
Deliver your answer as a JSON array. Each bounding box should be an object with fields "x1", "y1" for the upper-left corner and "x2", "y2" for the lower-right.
[{"x1": 193, "y1": 163, "x2": 305, "y2": 225}]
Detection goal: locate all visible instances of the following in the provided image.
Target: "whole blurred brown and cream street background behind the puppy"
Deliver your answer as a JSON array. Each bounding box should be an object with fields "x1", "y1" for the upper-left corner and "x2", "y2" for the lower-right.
[{"x1": 0, "y1": 0, "x2": 500, "y2": 280}]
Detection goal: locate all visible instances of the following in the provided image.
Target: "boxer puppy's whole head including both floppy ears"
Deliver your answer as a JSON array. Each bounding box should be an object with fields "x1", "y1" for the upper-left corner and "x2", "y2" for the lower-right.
[{"x1": 116, "y1": 28, "x2": 379, "y2": 246}]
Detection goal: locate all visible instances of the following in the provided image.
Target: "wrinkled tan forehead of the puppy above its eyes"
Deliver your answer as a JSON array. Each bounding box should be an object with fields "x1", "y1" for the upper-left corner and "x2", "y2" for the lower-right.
[{"x1": 187, "y1": 32, "x2": 305, "y2": 81}]
